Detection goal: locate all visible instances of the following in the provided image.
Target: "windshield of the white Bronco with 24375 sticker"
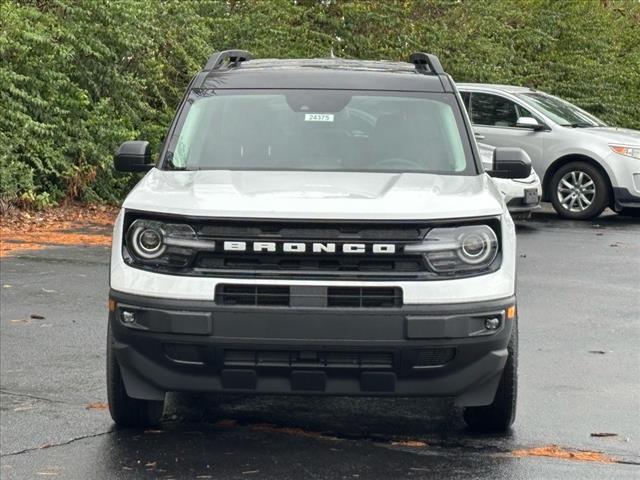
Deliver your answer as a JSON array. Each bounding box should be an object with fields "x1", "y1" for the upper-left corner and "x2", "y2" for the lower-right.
[{"x1": 164, "y1": 90, "x2": 477, "y2": 174}]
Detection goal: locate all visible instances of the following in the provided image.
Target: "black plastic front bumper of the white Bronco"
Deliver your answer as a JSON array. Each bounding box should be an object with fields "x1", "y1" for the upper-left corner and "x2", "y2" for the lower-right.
[{"x1": 109, "y1": 291, "x2": 516, "y2": 405}]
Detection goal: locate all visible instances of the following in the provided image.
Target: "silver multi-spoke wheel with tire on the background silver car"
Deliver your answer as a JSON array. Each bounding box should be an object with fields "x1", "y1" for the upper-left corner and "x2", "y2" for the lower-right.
[{"x1": 549, "y1": 162, "x2": 609, "y2": 220}]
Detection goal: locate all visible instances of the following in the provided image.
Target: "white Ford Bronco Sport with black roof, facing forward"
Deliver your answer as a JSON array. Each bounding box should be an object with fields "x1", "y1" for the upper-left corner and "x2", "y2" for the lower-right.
[{"x1": 107, "y1": 50, "x2": 531, "y2": 430}]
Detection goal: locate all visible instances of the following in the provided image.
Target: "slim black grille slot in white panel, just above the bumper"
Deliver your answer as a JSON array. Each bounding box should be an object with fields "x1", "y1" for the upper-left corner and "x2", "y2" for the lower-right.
[{"x1": 215, "y1": 284, "x2": 402, "y2": 308}]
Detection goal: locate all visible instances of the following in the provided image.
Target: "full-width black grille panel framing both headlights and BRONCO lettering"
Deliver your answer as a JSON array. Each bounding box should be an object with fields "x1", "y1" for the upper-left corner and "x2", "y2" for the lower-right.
[{"x1": 123, "y1": 214, "x2": 502, "y2": 281}]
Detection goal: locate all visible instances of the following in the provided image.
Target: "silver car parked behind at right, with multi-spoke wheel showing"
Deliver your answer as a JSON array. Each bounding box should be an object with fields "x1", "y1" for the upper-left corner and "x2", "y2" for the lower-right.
[{"x1": 457, "y1": 83, "x2": 640, "y2": 220}]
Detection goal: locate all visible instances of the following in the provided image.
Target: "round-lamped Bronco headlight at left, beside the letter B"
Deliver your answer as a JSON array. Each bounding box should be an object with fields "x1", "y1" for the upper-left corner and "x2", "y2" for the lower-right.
[{"x1": 125, "y1": 219, "x2": 215, "y2": 267}]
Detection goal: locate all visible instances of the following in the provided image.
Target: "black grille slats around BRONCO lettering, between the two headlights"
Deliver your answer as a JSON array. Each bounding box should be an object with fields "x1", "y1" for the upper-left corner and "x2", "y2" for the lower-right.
[{"x1": 193, "y1": 220, "x2": 429, "y2": 278}]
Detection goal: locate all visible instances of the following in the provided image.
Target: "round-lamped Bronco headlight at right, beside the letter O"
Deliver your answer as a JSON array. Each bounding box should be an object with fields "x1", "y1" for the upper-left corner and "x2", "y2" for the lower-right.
[{"x1": 405, "y1": 225, "x2": 498, "y2": 274}]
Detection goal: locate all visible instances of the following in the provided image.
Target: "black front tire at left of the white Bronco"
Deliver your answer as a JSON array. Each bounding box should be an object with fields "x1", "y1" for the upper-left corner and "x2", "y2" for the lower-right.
[{"x1": 107, "y1": 325, "x2": 164, "y2": 428}]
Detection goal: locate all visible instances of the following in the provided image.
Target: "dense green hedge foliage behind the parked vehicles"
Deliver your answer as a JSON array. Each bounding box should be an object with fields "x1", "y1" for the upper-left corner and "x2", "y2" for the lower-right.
[{"x1": 0, "y1": 0, "x2": 640, "y2": 206}]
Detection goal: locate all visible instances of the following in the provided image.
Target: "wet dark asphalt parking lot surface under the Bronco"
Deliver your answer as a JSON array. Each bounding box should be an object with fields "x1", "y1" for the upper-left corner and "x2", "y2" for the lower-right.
[{"x1": 0, "y1": 210, "x2": 640, "y2": 480}]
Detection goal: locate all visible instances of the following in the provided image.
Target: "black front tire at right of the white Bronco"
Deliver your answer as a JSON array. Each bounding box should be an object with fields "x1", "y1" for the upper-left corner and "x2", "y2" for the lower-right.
[{"x1": 463, "y1": 323, "x2": 518, "y2": 432}]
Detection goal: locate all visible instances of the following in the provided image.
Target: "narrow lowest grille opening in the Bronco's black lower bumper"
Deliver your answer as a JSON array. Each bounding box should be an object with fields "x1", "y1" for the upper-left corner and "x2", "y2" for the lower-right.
[{"x1": 224, "y1": 350, "x2": 393, "y2": 369}]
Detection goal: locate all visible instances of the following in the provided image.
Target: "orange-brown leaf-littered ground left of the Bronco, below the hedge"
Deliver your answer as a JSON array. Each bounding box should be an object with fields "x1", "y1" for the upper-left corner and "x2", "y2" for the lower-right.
[{"x1": 0, "y1": 204, "x2": 118, "y2": 257}]
